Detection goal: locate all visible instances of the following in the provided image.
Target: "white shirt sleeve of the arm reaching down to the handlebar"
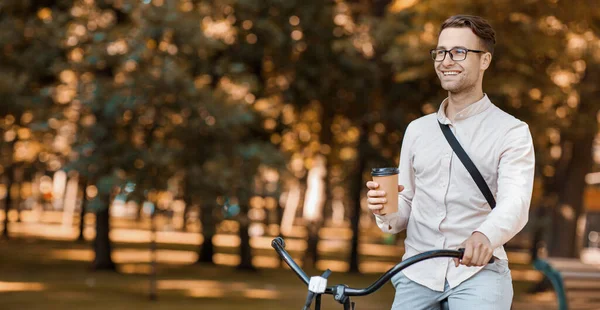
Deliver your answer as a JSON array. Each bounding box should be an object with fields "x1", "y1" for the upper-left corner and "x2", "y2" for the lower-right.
[{"x1": 475, "y1": 122, "x2": 535, "y2": 249}]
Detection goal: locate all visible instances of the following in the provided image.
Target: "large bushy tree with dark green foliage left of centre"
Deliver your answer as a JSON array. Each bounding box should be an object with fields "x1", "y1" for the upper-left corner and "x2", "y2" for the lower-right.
[{"x1": 56, "y1": 1, "x2": 288, "y2": 272}]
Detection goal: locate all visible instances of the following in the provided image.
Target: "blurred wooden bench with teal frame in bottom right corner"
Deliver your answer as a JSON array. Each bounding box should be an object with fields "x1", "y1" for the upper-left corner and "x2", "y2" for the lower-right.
[{"x1": 533, "y1": 258, "x2": 600, "y2": 310}]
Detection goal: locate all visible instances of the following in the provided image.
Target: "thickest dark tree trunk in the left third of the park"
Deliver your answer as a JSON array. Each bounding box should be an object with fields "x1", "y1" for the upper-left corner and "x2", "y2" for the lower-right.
[{"x1": 92, "y1": 195, "x2": 116, "y2": 271}]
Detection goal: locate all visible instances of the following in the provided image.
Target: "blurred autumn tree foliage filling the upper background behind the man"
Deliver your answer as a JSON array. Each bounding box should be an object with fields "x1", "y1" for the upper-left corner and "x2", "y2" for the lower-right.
[{"x1": 0, "y1": 0, "x2": 600, "y2": 235}]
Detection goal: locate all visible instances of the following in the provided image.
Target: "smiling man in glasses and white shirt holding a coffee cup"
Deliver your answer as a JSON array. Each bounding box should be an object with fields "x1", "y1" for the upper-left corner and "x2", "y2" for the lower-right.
[{"x1": 367, "y1": 15, "x2": 535, "y2": 310}]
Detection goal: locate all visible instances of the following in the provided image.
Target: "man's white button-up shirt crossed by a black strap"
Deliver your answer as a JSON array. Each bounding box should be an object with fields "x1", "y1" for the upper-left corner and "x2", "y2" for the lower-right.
[{"x1": 375, "y1": 95, "x2": 535, "y2": 291}]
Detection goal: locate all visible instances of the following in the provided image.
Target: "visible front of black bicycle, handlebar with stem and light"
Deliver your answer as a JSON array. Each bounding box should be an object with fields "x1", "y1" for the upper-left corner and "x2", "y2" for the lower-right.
[{"x1": 271, "y1": 237, "x2": 494, "y2": 310}]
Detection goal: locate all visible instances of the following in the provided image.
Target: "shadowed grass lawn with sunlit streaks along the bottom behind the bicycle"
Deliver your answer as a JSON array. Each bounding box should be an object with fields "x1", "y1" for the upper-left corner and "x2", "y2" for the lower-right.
[{"x1": 0, "y1": 238, "x2": 552, "y2": 310}]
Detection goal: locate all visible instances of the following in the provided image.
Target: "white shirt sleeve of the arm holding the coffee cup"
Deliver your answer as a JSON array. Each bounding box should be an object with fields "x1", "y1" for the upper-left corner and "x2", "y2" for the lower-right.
[{"x1": 375, "y1": 123, "x2": 415, "y2": 234}]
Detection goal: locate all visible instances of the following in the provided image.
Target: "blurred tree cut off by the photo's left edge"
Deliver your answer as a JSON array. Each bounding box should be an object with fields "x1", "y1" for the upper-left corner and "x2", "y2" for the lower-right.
[{"x1": 0, "y1": 1, "x2": 74, "y2": 237}]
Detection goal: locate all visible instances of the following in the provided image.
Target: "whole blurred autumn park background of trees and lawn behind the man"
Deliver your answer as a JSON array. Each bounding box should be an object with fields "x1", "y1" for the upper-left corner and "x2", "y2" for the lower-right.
[{"x1": 0, "y1": 0, "x2": 600, "y2": 309}]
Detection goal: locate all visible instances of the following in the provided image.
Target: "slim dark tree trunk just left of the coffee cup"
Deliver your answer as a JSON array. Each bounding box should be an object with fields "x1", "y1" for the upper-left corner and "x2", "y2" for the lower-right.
[{"x1": 350, "y1": 124, "x2": 369, "y2": 272}]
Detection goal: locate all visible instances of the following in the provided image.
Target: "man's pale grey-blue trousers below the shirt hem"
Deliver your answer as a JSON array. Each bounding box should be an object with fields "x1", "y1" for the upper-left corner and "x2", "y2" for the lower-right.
[{"x1": 392, "y1": 259, "x2": 514, "y2": 310}]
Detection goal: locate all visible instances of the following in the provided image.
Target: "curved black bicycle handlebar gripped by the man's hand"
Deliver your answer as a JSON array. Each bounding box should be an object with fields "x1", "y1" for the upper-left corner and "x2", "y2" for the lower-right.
[{"x1": 271, "y1": 237, "x2": 494, "y2": 296}]
